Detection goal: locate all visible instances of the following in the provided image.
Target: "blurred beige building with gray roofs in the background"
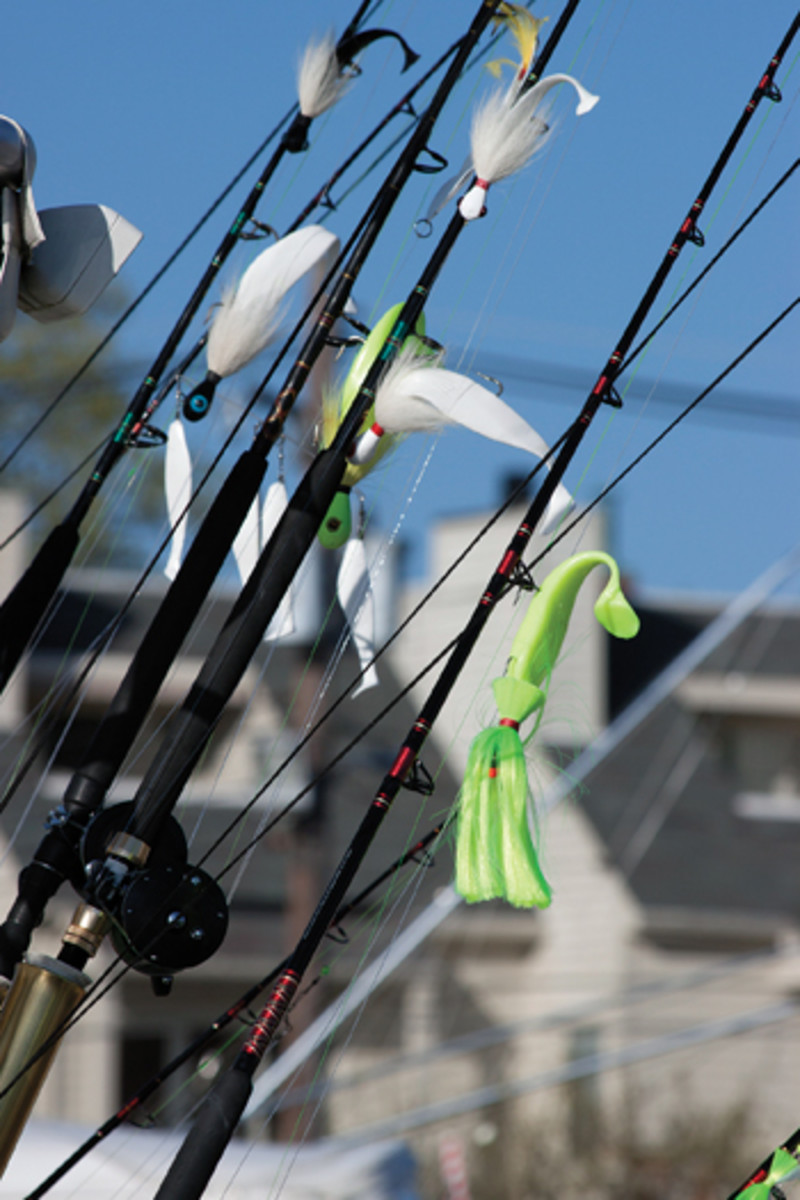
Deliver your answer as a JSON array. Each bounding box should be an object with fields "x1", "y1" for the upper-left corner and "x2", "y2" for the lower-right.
[{"x1": 0, "y1": 484, "x2": 800, "y2": 1194}]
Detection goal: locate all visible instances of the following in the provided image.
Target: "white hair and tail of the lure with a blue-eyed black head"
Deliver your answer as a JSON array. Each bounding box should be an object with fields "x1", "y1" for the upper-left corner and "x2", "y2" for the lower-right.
[{"x1": 207, "y1": 226, "x2": 339, "y2": 379}]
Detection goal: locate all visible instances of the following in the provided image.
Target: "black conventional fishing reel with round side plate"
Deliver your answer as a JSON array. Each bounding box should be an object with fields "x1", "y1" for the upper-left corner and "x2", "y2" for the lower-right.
[{"x1": 77, "y1": 802, "x2": 228, "y2": 995}]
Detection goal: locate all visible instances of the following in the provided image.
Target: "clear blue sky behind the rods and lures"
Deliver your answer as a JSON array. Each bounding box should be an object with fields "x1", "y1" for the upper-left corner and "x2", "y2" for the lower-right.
[{"x1": 2, "y1": 0, "x2": 800, "y2": 592}]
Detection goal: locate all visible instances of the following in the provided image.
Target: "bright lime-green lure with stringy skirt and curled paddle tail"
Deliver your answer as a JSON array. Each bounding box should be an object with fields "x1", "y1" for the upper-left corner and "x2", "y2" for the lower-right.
[{"x1": 456, "y1": 552, "x2": 639, "y2": 908}]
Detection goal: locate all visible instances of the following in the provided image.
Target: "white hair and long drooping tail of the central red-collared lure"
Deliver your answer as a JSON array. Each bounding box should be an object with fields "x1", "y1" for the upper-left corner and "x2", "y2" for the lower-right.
[{"x1": 375, "y1": 353, "x2": 573, "y2": 533}]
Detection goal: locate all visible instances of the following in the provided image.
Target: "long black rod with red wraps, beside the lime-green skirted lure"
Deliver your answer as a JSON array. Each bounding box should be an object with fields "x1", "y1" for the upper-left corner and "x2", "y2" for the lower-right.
[{"x1": 146, "y1": 14, "x2": 800, "y2": 1200}]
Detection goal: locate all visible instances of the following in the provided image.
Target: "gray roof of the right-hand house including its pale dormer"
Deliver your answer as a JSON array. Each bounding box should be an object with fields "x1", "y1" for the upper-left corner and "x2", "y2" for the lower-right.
[{"x1": 579, "y1": 592, "x2": 800, "y2": 947}]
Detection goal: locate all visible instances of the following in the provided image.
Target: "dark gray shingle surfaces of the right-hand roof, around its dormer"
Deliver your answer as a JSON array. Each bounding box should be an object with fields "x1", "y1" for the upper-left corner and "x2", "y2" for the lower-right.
[{"x1": 579, "y1": 606, "x2": 800, "y2": 941}]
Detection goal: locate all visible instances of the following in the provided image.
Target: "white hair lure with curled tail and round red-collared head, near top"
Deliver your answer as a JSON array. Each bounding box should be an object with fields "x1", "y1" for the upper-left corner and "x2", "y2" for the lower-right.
[{"x1": 458, "y1": 74, "x2": 600, "y2": 221}]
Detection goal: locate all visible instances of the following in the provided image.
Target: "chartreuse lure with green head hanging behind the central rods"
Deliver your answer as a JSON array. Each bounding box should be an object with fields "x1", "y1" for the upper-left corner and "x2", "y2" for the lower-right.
[{"x1": 318, "y1": 304, "x2": 431, "y2": 550}]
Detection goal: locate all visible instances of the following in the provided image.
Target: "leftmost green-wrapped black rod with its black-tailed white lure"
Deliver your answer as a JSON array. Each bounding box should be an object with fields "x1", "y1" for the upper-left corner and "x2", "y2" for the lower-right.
[{"x1": 0, "y1": 0, "x2": 417, "y2": 689}]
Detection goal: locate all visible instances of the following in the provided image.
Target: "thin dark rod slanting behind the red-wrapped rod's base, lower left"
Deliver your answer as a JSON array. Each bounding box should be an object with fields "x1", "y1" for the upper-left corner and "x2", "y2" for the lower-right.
[{"x1": 25, "y1": 822, "x2": 446, "y2": 1200}]
